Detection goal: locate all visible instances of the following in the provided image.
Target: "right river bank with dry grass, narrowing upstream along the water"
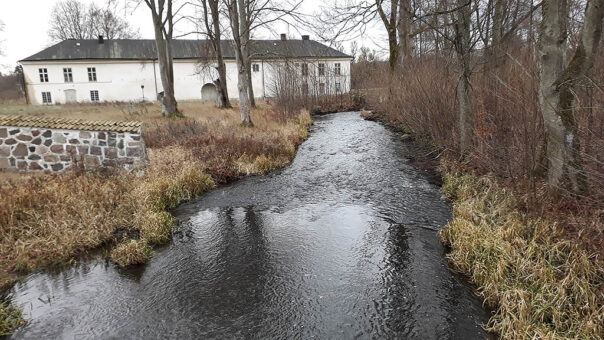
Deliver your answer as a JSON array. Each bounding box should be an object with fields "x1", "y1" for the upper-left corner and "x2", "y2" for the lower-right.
[{"x1": 364, "y1": 112, "x2": 604, "y2": 339}]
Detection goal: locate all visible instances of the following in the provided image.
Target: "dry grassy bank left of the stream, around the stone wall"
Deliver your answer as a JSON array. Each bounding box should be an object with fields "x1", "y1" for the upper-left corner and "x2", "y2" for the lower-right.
[{"x1": 0, "y1": 101, "x2": 311, "y2": 333}]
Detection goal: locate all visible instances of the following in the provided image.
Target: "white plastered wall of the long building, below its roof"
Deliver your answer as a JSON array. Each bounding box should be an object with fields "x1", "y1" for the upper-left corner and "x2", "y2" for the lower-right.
[{"x1": 23, "y1": 59, "x2": 350, "y2": 105}]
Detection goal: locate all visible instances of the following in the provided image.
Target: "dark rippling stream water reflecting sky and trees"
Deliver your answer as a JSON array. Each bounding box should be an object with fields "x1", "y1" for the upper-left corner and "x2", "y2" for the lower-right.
[{"x1": 9, "y1": 112, "x2": 488, "y2": 339}]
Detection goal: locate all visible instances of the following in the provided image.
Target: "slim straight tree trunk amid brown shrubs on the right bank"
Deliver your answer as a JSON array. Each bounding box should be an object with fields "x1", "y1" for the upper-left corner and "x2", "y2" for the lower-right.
[{"x1": 455, "y1": 0, "x2": 474, "y2": 155}]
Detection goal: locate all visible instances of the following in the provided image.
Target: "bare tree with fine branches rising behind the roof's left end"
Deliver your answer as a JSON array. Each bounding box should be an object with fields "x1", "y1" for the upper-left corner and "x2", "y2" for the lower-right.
[{"x1": 48, "y1": 0, "x2": 139, "y2": 41}]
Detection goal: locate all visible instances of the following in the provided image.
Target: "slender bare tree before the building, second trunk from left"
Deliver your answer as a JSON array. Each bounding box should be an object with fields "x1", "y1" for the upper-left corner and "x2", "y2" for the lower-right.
[{"x1": 200, "y1": 0, "x2": 231, "y2": 108}]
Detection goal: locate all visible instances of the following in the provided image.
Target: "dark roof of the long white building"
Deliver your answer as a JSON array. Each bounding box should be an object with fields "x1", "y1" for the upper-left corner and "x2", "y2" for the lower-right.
[{"x1": 21, "y1": 39, "x2": 351, "y2": 61}]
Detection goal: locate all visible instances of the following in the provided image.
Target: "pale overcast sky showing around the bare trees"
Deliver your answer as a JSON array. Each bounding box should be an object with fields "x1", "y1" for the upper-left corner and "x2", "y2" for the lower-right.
[{"x1": 0, "y1": 0, "x2": 386, "y2": 71}]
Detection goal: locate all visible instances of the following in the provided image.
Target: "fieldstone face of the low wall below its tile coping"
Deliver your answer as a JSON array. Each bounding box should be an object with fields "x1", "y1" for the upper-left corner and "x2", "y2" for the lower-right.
[{"x1": 0, "y1": 126, "x2": 147, "y2": 173}]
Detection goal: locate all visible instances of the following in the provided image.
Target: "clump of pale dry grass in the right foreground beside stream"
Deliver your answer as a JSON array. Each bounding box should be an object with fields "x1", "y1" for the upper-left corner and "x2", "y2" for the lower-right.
[{"x1": 441, "y1": 174, "x2": 604, "y2": 339}]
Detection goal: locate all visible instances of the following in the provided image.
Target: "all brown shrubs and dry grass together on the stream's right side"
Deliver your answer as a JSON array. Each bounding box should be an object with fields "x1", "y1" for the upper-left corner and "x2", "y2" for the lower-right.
[{"x1": 353, "y1": 1, "x2": 604, "y2": 339}]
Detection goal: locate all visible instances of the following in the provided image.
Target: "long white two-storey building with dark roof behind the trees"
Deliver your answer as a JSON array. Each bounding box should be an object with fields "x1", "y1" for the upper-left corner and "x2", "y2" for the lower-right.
[{"x1": 20, "y1": 35, "x2": 352, "y2": 104}]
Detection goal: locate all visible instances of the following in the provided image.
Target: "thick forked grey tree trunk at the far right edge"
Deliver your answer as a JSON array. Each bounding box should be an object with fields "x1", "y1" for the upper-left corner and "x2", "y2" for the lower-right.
[{"x1": 540, "y1": 0, "x2": 604, "y2": 193}]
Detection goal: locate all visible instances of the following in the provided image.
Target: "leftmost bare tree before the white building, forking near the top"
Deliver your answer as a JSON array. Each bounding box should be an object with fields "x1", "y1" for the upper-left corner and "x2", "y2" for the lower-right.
[{"x1": 143, "y1": 0, "x2": 182, "y2": 116}]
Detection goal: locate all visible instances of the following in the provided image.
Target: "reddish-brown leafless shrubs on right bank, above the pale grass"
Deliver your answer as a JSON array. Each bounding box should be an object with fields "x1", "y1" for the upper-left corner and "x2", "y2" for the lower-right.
[{"x1": 360, "y1": 51, "x2": 604, "y2": 257}]
